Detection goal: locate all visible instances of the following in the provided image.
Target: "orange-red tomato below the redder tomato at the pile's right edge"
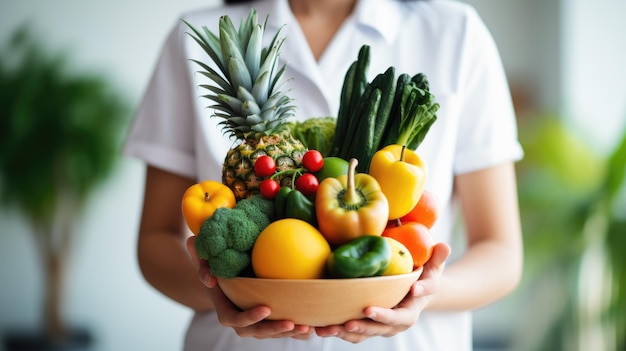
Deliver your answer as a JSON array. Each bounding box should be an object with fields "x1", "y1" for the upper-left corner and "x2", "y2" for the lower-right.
[{"x1": 383, "y1": 222, "x2": 435, "y2": 268}]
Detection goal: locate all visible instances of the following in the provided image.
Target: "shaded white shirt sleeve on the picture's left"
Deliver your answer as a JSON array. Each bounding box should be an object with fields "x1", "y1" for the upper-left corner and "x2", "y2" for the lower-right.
[{"x1": 123, "y1": 20, "x2": 196, "y2": 178}]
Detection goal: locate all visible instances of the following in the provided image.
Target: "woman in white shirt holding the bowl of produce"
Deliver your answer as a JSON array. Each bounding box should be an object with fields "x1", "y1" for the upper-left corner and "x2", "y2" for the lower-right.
[{"x1": 126, "y1": 0, "x2": 522, "y2": 351}]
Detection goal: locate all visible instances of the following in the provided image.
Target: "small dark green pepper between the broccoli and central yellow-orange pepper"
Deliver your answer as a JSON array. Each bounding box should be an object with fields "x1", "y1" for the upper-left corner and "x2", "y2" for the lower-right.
[{"x1": 274, "y1": 186, "x2": 317, "y2": 226}]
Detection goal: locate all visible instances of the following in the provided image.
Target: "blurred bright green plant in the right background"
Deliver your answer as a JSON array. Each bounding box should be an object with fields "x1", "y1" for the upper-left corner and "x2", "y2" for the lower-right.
[{"x1": 516, "y1": 116, "x2": 626, "y2": 351}]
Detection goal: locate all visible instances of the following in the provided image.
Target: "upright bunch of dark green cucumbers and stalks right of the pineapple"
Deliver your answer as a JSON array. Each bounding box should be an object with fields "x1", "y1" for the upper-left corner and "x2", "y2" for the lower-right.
[{"x1": 330, "y1": 45, "x2": 439, "y2": 161}]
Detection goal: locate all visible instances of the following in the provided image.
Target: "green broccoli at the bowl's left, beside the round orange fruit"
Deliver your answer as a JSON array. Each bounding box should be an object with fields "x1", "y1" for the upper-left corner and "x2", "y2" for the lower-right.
[{"x1": 195, "y1": 195, "x2": 274, "y2": 278}]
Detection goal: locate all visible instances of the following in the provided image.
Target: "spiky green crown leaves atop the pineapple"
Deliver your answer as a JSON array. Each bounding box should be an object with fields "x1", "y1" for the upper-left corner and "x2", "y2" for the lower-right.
[{"x1": 183, "y1": 9, "x2": 295, "y2": 139}]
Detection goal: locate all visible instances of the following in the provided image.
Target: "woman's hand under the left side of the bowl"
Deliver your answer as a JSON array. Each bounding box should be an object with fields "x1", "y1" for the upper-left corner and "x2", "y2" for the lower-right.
[{"x1": 187, "y1": 236, "x2": 313, "y2": 339}]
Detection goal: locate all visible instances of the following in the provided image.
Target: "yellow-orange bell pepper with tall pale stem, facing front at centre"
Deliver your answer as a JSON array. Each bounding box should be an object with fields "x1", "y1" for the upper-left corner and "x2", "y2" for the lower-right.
[{"x1": 315, "y1": 159, "x2": 389, "y2": 245}]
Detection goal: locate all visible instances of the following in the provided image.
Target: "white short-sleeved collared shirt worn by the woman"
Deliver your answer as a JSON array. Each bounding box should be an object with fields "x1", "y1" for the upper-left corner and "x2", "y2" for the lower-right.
[{"x1": 125, "y1": 0, "x2": 522, "y2": 351}]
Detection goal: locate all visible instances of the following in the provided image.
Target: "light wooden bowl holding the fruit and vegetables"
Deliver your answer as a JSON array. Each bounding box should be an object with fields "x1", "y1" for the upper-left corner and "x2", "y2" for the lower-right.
[{"x1": 218, "y1": 267, "x2": 422, "y2": 326}]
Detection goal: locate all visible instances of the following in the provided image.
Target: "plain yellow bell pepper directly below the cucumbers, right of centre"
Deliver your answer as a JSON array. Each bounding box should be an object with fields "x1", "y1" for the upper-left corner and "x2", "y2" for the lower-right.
[{"x1": 369, "y1": 144, "x2": 428, "y2": 219}]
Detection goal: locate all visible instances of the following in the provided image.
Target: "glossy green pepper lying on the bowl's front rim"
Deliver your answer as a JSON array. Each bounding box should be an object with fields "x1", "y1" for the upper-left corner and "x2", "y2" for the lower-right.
[{"x1": 327, "y1": 235, "x2": 391, "y2": 278}]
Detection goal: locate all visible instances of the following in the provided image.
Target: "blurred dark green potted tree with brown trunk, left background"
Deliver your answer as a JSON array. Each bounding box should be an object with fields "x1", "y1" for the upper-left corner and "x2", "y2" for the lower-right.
[{"x1": 0, "y1": 27, "x2": 129, "y2": 346}]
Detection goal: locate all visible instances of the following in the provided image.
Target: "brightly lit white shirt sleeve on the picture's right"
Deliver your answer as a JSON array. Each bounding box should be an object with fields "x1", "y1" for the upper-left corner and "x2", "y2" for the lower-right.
[{"x1": 454, "y1": 8, "x2": 523, "y2": 174}]
